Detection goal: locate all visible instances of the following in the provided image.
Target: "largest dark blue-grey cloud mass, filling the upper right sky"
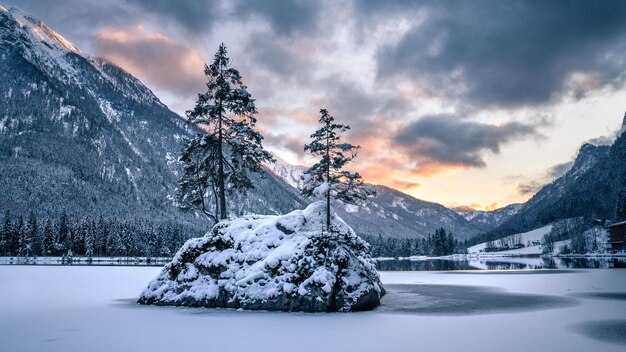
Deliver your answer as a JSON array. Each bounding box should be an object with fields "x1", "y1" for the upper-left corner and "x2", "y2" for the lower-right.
[{"x1": 372, "y1": 0, "x2": 626, "y2": 107}]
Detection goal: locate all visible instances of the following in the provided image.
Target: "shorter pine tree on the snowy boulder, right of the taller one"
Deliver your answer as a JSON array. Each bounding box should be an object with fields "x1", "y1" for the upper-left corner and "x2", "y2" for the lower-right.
[{"x1": 302, "y1": 109, "x2": 366, "y2": 230}]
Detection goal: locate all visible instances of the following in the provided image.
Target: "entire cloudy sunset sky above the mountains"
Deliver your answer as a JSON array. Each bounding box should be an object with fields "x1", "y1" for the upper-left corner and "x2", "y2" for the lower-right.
[{"x1": 0, "y1": 0, "x2": 626, "y2": 209}]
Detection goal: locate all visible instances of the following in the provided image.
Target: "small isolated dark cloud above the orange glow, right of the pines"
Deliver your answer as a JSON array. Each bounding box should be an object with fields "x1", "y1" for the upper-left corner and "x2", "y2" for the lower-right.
[{"x1": 393, "y1": 115, "x2": 539, "y2": 170}]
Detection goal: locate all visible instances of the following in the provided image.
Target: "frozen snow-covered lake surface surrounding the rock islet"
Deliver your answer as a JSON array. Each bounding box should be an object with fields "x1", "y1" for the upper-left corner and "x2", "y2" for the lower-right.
[{"x1": 0, "y1": 265, "x2": 626, "y2": 352}]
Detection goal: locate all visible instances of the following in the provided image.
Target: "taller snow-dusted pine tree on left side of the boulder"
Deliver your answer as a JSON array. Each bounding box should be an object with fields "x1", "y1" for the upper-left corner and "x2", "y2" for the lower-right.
[{"x1": 178, "y1": 44, "x2": 273, "y2": 220}]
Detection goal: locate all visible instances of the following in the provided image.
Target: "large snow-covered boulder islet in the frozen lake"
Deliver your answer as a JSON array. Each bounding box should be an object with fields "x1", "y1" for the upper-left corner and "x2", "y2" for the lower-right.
[{"x1": 139, "y1": 202, "x2": 385, "y2": 312}]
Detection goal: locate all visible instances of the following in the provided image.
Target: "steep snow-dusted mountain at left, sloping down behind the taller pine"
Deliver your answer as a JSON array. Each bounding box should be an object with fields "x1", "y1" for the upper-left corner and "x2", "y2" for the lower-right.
[{"x1": 0, "y1": 8, "x2": 305, "y2": 231}]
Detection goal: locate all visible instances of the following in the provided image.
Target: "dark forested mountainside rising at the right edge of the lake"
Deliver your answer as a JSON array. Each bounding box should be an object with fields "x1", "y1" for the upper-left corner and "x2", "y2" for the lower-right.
[{"x1": 491, "y1": 116, "x2": 626, "y2": 235}]
